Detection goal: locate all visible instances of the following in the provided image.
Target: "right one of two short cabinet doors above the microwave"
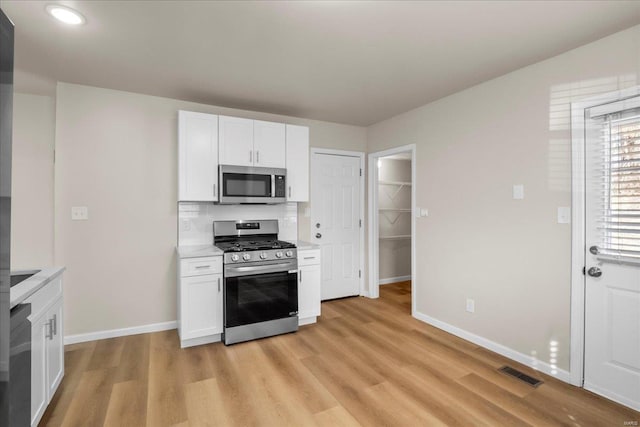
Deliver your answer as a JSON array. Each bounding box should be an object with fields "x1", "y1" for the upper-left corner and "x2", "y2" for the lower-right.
[{"x1": 253, "y1": 120, "x2": 286, "y2": 169}]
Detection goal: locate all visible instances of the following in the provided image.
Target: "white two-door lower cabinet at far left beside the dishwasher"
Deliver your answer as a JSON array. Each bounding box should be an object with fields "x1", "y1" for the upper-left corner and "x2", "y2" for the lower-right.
[{"x1": 25, "y1": 277, "x2": 64, "y2": 426}]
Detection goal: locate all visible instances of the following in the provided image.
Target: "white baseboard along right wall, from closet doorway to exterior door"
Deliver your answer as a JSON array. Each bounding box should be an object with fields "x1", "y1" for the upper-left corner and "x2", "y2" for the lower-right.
[{"x1": 413, "y1": 311, "x2": 571, "y2": 384}]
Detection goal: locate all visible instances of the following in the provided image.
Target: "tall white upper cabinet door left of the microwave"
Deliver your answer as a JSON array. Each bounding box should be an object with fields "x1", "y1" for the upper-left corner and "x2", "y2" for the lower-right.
[{"x1": 178, "y1": 111, "x2": 218, "y2": 201}]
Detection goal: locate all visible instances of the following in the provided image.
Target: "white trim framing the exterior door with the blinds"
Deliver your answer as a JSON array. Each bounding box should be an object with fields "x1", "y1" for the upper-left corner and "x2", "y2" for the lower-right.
[{"x1": 569, "y1": 86, "x2": 640, "y2": 387}]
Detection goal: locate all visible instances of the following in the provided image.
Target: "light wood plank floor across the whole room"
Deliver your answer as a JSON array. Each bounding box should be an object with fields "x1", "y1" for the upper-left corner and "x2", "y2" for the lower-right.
[{"x1": 41, "y1": 282, "x2": 640, "y2": 427}]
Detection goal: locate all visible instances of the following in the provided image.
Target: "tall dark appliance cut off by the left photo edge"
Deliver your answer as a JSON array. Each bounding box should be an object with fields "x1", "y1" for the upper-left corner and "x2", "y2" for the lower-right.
[{"x1": 0, "y1": 9, "x2": 13, "y2": 426}]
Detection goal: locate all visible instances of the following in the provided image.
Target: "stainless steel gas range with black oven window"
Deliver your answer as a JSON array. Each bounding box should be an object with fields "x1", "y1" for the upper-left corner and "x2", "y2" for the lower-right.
[{"x1": 213, "y1": 220, "x2": 298, "y2": 345}]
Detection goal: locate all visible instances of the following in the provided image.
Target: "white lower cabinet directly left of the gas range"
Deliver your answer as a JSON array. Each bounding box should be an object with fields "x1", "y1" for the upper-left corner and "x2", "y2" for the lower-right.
[{"x1": 178, "y1": 256, "x2": 223, "y2": 348}]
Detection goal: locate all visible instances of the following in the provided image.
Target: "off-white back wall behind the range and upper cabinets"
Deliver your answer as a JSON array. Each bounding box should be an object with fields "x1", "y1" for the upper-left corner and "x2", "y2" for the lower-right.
[{"x1": 55, "y1": 83, "x2": 366, "y2": 335}]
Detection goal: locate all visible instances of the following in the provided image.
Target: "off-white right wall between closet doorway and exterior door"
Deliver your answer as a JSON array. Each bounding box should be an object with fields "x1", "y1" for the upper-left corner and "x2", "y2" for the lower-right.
[{"x1": 368, "y1": 27, "x2": 640, "y2": 370}]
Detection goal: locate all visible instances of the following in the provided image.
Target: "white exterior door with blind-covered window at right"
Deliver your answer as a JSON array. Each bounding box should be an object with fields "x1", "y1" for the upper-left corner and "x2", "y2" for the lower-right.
[{"x1": 584, "y1": 98, "x2": 640, "y2": 410}]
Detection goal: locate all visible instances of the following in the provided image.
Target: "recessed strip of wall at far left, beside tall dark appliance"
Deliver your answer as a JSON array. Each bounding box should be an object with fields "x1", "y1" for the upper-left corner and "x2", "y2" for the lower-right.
[{"x1": 11, "y1": 93, "x2": 55, "y2": 270}]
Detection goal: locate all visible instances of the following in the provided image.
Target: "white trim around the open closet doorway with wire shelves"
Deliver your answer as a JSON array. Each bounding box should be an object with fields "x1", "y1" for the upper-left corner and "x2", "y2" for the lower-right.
[{"x1": 367, "y1": 144, "x2": 417, "y2": 316}]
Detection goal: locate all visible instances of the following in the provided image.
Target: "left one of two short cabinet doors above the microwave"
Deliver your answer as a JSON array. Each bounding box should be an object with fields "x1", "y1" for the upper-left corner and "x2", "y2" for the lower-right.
[{"x1": 219, "y1": 116, "x2": 254, "y2": 166}]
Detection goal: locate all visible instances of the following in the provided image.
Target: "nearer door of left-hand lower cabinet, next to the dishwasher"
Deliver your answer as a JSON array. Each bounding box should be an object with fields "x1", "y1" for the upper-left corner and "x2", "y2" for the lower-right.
[{"x1": 31, "y1": 313, "x2": 50, "y2": 426}]
